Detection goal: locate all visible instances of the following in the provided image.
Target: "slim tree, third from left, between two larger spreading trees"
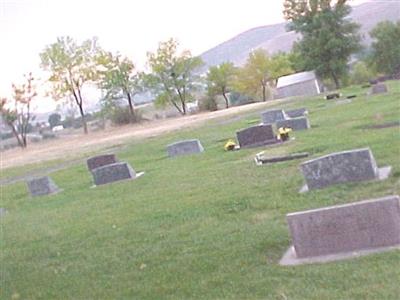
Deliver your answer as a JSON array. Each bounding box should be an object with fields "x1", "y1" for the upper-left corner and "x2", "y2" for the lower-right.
[{"x1": 98, "y1": 52, "x2": 143, "y2": 122}]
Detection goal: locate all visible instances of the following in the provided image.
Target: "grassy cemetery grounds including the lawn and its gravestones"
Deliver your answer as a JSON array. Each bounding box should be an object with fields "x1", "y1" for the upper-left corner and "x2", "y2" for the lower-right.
[{"x1": 0, "y1": 81, "x2": 400, "y2": 299}]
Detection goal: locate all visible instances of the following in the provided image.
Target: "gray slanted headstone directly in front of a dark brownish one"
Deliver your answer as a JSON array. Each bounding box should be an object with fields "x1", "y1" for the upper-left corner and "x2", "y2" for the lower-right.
[{"x1": 92, "y1": 162, "x2": 136, "y2": 185}]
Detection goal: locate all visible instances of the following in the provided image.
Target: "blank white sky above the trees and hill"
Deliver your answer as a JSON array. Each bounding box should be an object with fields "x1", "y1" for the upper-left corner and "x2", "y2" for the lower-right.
[{"x1": 0, "y1": 0, "x2": 367, "y2": 112}]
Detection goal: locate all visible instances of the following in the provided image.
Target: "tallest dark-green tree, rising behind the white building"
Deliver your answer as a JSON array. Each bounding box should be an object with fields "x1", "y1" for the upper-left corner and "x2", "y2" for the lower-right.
[{"x1": 284, "y1": 0, "x2": 361, "y2": 88}]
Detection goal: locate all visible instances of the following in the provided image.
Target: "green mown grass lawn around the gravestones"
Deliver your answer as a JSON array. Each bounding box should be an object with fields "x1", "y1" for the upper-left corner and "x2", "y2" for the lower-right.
[{"x1": 0, "y1": 82, "x2": 400, "y2": 299}]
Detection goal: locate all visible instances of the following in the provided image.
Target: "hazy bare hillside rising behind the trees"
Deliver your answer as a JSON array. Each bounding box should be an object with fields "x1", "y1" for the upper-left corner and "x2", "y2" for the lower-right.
[{"x1": 201, "y1": 1, "x2": 400, "y2": 69}]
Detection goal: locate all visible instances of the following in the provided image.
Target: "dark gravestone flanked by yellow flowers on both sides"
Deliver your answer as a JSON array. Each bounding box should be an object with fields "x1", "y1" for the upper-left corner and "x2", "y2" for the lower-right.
[{"x1": 236, "y1": 124, "x2": 279, "y2": 148}]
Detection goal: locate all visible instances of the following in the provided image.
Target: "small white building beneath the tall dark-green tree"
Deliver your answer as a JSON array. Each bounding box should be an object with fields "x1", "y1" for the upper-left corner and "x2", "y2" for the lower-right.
[{"x1": 276, "y1": 71, "x2": 323, "y2": 98}]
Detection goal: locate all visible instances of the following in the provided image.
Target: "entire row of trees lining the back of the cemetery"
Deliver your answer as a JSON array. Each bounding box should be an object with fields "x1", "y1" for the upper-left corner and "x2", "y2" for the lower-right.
[{"x1": 0, "y1": 0, "x2": 400, "y2": 147}]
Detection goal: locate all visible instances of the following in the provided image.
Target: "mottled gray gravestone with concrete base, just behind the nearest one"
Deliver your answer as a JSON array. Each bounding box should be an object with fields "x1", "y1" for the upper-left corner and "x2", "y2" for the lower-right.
[{"x1": 300, "y1": 148, "x2": 391, "y2": 191}]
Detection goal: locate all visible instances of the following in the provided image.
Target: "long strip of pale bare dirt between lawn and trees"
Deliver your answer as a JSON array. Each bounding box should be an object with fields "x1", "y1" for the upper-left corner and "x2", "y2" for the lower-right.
[{"x1": 1, "y1": 100, "x2": 288, "y2": 170}]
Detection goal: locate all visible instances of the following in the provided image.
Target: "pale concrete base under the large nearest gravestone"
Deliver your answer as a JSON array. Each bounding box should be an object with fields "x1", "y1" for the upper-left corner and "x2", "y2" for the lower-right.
[{"x1": 279, "y1": 244, "x2": 400, "y2": 266}]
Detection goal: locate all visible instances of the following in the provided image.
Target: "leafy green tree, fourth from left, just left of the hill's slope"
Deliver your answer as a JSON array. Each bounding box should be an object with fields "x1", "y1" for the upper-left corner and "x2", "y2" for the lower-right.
[{"x1": 146, "y1": 39, "x2": 203, "y2": 115}]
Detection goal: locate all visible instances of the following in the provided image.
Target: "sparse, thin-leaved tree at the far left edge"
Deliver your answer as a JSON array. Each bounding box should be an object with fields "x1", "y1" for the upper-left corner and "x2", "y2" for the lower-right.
[{"x1": 0, "y1": 73, "x2": 37, "y2": 148}]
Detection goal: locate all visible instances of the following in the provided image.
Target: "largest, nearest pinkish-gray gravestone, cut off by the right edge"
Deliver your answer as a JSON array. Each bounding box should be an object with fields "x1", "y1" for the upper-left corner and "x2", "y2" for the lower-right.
[{"x1": 281, "y1": 196, "x2": 400, "y2": 264}]
